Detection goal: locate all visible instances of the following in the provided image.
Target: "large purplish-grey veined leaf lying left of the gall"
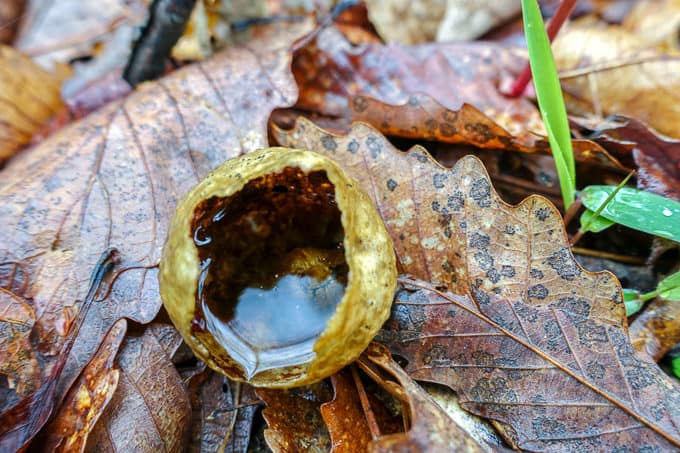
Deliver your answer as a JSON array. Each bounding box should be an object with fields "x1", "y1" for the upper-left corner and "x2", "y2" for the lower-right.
[{"x1": 0, "y1": 18, "x2": 311, "y2": 448}]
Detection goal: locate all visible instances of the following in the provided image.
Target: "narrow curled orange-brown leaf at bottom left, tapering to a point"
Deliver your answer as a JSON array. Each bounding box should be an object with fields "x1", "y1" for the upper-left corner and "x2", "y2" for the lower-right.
[{"x1": 34, "y1": 319, "x2": 127, "y2": 452}]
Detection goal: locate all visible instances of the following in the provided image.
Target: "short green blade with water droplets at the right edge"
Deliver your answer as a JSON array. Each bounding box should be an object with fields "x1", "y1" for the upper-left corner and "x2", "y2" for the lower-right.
[{"x1": 581, "y1": 186, "x2": 680, "y2": 242}]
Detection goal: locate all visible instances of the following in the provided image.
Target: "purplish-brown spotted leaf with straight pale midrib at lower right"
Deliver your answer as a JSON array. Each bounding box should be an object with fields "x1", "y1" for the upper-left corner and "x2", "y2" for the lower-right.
[{"x1": 379, "y1": 279, "x2": 680, "y2": 451}]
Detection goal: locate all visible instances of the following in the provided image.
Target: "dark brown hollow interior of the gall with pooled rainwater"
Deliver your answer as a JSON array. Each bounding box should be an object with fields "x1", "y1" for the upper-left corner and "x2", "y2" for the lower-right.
[{"x1": 192, "y1": 167, "x2": 348, "y2": 379}]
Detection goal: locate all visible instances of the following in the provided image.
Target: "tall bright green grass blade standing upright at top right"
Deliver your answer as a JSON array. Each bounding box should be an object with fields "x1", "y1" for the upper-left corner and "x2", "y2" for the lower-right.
[{"x1": 522, "y1": 0, "x2": 576, "y2": 209}]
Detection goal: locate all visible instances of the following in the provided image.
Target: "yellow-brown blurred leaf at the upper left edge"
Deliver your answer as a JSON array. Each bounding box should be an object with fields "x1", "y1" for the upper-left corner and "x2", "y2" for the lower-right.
[{"x1": 0, "y1": 44, "x2": 62, "y2": 162}]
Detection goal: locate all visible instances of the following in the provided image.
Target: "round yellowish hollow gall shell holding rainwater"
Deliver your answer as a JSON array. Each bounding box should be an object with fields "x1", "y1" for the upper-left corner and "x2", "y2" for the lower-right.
[{"x1": 159, "y1": 148, "x2": 396, "y2": 387}]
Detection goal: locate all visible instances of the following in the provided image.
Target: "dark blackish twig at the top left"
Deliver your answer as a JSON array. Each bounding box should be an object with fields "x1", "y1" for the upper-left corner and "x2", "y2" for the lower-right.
[{"x1": 123, "y1": 0, "x2": 196, "y2": 86}]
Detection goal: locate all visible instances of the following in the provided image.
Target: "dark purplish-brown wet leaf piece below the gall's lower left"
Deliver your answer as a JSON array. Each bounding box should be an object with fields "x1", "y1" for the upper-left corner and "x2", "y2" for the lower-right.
[{"x1": 187, "y1": 369, "x2": 257, "y2": 453}]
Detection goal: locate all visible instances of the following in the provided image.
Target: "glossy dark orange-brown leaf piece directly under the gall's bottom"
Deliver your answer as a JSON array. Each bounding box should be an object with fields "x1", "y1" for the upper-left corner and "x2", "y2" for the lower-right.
[{"x1": 256, "y1": 381, "x2": 332, "y2": 453}]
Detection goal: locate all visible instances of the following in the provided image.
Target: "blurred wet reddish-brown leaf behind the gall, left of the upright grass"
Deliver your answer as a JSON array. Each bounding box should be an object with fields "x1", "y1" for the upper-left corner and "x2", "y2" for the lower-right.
[{"x1": 293, "y1": 27, "x2": 545, "y2": 135}]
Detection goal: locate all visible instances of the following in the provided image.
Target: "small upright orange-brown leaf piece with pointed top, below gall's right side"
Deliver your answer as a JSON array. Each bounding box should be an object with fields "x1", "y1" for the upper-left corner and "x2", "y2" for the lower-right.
[{"x1": 321, "y1": 368, "x2": 371, "y2": 453}]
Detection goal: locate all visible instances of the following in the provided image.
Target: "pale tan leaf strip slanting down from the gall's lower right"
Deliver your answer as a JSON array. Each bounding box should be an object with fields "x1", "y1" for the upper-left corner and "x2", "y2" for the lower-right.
[{"x1": 359, "y1": 343, "x2": 486, "y2": 452}]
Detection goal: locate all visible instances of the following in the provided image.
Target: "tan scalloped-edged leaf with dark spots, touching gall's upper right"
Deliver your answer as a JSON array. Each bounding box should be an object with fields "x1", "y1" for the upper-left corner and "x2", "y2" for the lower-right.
[{"x1": 276, "y1": 119, "x2": 625, "y2": 327}]
